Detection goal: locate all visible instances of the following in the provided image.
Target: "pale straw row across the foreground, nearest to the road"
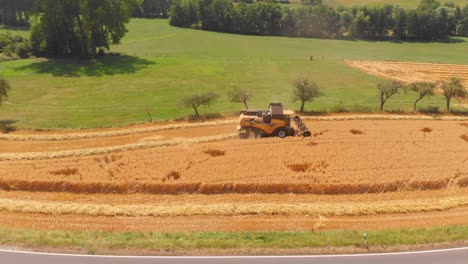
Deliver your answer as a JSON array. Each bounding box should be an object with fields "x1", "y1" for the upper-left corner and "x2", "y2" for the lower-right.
[{"x1": 0, "y1": 196, "x2": 468, "y2": 217}]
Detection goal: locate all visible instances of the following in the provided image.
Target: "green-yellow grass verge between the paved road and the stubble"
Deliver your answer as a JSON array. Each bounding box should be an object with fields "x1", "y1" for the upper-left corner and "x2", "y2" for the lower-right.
[{"x1": 0, "y1": 226, "x2": 468, "y2": 255}]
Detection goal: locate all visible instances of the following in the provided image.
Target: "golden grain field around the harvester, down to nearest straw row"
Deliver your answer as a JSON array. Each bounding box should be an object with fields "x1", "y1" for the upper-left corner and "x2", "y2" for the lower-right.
[{"x1": 0, "y1": 116, "x2": 468, "y2": 231}]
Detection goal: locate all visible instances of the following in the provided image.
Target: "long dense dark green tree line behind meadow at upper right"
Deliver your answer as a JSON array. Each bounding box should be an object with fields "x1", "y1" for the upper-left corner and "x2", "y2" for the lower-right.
[{"x1": 169, "y1": 0, "x2": 468, "y2": 41}]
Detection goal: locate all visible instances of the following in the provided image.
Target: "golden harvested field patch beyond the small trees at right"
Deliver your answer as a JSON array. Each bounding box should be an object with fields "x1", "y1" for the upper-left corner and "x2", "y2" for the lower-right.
[{"x1": 345, "y1": 61, "x2": 468, "y2": 87}]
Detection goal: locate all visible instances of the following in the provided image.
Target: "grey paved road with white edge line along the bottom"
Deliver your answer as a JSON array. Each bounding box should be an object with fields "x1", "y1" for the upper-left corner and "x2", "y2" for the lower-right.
[{"x1": 0, "y1": 247, "x2": 468, "y2": 264}]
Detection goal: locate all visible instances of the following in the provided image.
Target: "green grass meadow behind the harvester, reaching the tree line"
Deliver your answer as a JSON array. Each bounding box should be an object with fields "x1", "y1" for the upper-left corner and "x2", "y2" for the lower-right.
[{"x1": 0, "y1": 19, "x2": 468, "y2": 128}]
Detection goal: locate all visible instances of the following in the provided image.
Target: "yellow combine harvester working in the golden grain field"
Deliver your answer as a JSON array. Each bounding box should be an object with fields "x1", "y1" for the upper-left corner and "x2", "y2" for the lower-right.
[{"x1": 237, "y1": 103, "x2": 312, "y2": 138}]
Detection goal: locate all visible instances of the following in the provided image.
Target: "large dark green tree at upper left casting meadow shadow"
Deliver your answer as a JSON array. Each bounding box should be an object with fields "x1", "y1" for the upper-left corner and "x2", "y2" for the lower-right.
[{"x1": 31, "y1": 0, "x2": 139, "y2": 59}]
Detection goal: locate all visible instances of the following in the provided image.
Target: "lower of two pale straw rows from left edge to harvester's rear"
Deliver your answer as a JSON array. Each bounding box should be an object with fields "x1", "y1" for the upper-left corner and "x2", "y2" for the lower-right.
[{"x1": 0, "y1": 133, "x2": 238, "y2": 161}]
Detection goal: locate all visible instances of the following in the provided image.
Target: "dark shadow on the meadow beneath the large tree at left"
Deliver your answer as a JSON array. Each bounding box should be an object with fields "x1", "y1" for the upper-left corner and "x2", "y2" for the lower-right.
[{"x1": 15, "y1": 54, "x2": 155, "y2": 77}]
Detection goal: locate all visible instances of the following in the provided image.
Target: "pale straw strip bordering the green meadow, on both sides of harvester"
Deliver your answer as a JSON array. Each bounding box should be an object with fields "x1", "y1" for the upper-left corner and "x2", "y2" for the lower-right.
[{"x1": 0, "y1": 114, "x2": 468, "y2": 141}]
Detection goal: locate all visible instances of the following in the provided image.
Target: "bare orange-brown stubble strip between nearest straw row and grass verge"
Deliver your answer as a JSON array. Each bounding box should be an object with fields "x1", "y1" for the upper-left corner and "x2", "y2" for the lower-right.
[{"x1": 0, "y1": 207, "x2": 468, "y2": 232}]
